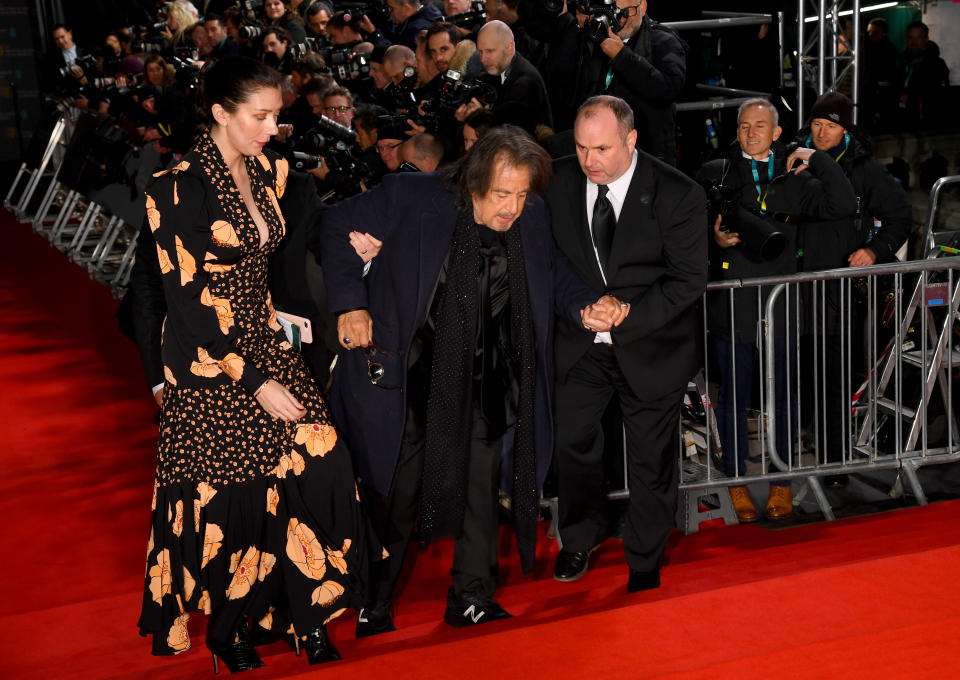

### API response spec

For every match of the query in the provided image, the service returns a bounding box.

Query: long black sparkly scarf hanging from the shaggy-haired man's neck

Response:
[420,201,539,572]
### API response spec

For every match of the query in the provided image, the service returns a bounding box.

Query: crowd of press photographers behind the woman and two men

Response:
[42,0,704,202]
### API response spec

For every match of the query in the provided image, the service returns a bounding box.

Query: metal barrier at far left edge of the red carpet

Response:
[3,109,139,298]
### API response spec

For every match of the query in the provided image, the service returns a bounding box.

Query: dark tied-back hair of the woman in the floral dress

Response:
[197,57,283,126]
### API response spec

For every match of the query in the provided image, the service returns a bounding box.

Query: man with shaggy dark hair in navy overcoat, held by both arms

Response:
[322,125,628,636]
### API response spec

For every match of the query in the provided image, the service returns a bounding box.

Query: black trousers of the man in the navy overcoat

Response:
[367,410,501,601]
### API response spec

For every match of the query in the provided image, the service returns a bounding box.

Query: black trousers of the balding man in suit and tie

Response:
[555,344,683,572]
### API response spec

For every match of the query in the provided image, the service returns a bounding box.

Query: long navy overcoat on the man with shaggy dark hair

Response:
[322,173,596,494]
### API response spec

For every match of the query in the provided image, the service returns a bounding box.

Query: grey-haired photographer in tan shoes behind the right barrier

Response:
[698,99,856,522]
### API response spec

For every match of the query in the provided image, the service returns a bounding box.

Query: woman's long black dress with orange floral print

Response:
[139,133,379,655]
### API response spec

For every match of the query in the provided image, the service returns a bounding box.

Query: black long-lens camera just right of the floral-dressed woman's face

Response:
[291,116,377,202]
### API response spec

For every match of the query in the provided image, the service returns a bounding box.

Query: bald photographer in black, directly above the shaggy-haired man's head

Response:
[457,20,553,137]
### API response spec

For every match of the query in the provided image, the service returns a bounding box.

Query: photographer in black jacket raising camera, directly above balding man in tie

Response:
[548,0,686,165]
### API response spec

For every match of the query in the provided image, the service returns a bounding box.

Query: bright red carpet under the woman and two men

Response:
[0,212,960,680]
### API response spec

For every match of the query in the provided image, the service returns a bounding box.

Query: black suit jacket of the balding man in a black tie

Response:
[547,151,707,399]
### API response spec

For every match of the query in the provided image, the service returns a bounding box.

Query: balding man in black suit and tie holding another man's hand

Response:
[547,95,707,592]
